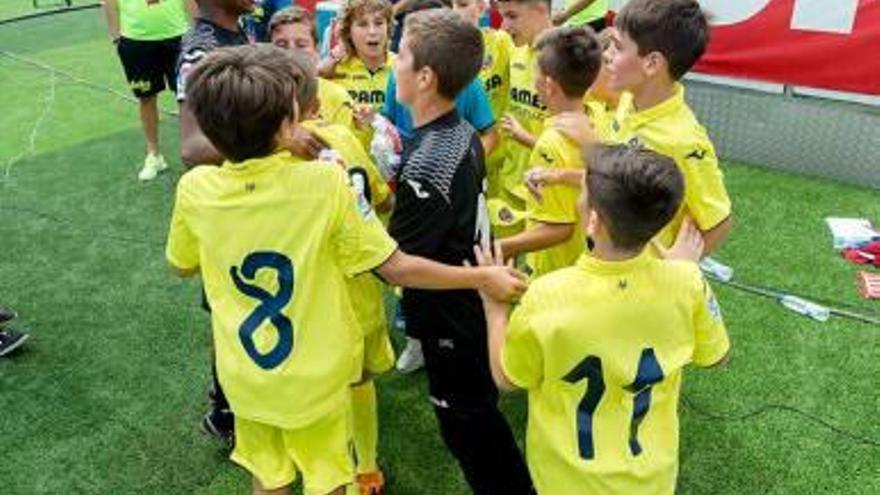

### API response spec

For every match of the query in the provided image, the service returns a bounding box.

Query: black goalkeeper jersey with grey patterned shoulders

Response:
[389,110,490,340]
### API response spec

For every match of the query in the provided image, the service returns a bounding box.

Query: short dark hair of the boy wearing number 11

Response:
[586,145,684,250]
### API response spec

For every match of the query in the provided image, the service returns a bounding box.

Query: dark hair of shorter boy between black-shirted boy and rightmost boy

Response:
[535,27,602,98]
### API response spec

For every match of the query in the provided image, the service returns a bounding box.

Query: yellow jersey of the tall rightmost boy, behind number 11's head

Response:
[613,84,731,252]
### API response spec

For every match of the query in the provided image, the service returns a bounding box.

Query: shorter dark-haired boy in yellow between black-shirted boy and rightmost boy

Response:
[501,27,602,278]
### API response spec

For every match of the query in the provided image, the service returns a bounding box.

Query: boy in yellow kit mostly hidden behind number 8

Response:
[295,53,394,495]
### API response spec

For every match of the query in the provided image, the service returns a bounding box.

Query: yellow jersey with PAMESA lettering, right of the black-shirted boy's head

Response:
[501,45,549,207]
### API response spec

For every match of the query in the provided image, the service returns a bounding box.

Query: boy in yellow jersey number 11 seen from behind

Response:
[482,145,730,495]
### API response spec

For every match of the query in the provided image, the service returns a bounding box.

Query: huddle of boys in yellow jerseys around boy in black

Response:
[167,0,731,495]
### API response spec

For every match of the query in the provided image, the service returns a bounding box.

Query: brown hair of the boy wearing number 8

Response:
[186,44,302,162]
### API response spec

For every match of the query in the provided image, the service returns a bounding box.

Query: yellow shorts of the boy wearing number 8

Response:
[230,407,354,495]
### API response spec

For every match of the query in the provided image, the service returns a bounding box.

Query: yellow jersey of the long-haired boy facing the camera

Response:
[333,53,394,149]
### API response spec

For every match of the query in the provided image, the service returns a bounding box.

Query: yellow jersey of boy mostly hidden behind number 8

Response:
[303,121,391,335]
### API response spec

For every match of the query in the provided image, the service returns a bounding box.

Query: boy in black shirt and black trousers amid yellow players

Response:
[389,9,532,495]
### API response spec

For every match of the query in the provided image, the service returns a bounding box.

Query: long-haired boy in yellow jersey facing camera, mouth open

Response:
[319,0,394,149]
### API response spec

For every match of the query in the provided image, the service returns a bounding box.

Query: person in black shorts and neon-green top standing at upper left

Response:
[104,0,195,181]
